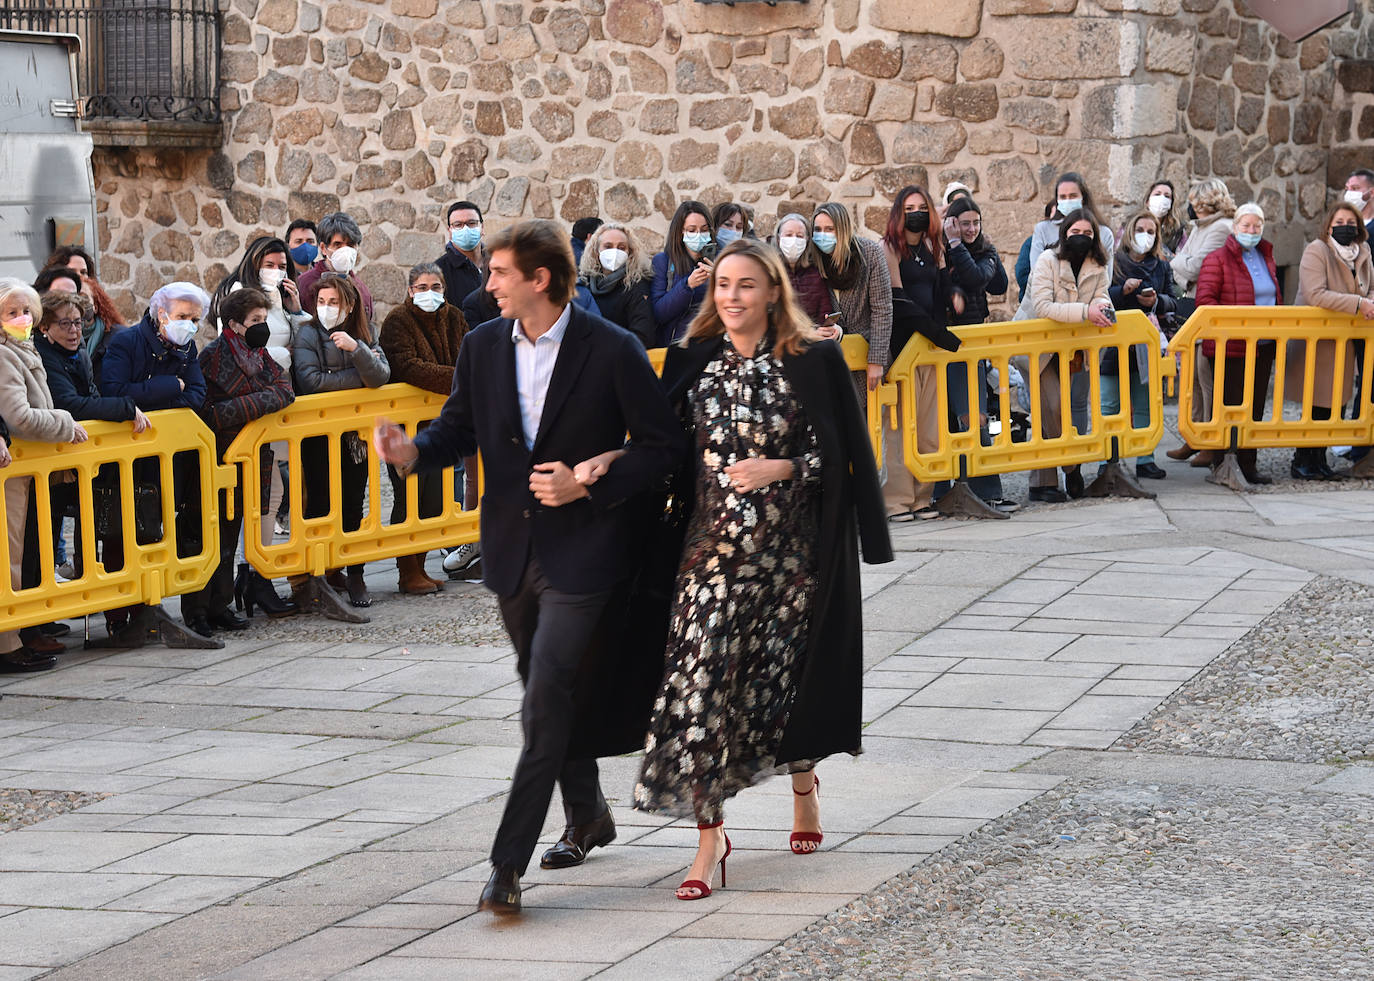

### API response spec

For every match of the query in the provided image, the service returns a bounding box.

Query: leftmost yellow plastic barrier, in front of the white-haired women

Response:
[0,409,234,629]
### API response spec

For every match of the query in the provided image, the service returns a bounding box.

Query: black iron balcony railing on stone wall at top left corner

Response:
[0,0,220,124]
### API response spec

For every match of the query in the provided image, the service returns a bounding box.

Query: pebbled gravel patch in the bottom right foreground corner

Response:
[734,782,1374,981]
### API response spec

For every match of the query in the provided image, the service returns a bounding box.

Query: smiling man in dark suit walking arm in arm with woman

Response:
[375,221,684,914]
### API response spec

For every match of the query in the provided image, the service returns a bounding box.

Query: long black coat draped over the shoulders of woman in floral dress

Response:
[651,337,892,763]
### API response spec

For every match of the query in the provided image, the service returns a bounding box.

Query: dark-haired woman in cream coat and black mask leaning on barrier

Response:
[1026,209,1113,503]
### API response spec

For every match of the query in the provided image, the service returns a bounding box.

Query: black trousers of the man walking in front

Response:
[492,556,614,875]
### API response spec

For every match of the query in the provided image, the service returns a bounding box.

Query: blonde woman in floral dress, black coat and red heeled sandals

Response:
[588,239,892,900]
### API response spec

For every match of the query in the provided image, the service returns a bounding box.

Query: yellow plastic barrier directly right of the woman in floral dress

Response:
[888,311,1173,481]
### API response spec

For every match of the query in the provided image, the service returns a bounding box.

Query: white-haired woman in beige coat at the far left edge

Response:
[0,279,87,673]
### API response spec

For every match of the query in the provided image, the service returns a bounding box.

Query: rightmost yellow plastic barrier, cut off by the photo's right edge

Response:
[1171,306,1374,449]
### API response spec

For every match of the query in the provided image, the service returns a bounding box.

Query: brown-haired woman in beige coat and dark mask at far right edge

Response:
[1283,201,1374,481]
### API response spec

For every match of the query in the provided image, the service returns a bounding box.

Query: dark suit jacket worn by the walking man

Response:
[415,306,686,598]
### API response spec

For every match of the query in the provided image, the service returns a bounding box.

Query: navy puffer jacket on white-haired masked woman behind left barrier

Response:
[100,313,205,412]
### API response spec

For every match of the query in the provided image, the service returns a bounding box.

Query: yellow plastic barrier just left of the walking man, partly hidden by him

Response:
[224,385,480,578]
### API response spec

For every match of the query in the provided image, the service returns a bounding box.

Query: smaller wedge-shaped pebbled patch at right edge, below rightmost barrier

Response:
[1117,578,1374,764]
